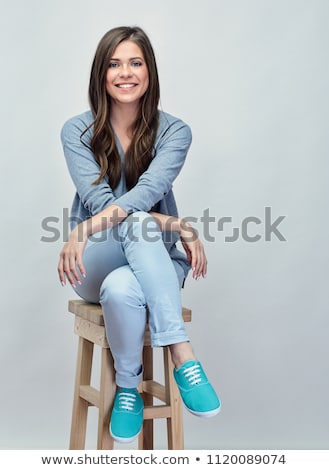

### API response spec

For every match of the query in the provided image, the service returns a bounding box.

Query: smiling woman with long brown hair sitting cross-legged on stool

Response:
[58,27,220,442]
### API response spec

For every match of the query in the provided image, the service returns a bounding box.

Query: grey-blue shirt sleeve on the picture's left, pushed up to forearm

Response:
[61,118,116,216]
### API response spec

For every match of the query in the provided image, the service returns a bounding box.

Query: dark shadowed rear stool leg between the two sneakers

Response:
[138,346,154,450]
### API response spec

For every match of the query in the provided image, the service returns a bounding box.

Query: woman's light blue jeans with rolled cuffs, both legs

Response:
[75,212,189,388]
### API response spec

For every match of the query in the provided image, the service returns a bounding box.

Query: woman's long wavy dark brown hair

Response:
[84,26,160,190]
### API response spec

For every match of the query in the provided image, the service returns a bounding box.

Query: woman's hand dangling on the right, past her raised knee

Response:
[180,220,208,279]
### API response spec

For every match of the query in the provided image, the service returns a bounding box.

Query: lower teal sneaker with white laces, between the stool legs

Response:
[110,388,144,443]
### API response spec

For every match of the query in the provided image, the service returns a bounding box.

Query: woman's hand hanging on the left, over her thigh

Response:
[57,223,88,287]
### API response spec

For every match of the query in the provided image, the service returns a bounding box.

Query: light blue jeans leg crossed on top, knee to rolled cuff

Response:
[117,212,189,347]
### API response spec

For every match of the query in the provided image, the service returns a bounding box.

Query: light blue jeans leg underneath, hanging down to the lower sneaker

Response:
[75,230,146,388]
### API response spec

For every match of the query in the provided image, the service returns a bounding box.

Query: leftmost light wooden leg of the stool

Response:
[70,336,94,450]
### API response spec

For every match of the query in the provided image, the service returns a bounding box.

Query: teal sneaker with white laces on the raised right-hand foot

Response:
[174,361,220,418]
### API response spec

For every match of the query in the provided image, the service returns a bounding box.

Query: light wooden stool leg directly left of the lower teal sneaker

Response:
[97,348,116,450]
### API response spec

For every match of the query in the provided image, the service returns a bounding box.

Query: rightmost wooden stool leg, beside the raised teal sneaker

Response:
[163,347,184,450]
